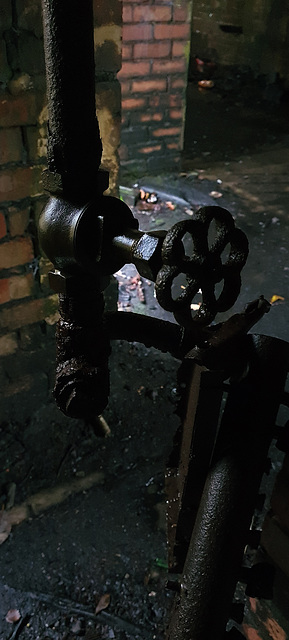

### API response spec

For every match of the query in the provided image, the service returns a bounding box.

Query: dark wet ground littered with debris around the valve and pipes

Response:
[0,81,289,640]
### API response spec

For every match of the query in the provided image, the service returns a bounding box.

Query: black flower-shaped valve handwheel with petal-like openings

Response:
[156,206,248,326]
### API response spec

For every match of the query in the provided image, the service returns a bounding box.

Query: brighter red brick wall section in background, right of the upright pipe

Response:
[118,0,191,171]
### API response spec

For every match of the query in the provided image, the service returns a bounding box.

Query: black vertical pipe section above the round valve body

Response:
[42,0,102,201]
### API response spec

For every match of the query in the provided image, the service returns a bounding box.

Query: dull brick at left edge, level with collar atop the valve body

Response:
[0,166,43,202]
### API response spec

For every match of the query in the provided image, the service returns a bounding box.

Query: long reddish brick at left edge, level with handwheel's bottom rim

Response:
[0,295,58,331]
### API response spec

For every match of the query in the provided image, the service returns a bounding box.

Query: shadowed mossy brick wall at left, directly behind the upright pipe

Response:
[0,0,122,422]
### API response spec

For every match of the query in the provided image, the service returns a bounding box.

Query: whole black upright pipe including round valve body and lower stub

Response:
[39,0,110,419]
